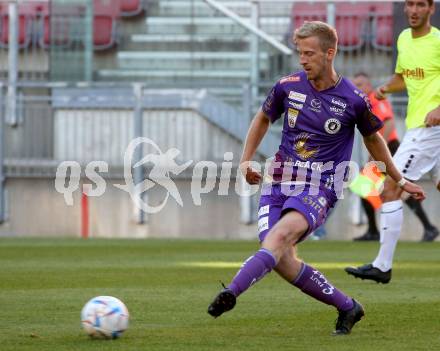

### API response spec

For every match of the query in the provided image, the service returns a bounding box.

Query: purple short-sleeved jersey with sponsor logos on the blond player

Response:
[262,71,383,201]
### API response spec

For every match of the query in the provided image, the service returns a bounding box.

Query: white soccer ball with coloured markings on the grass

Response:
[81,296,129,339]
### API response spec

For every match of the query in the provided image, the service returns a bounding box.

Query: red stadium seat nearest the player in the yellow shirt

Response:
[371,2,394,51]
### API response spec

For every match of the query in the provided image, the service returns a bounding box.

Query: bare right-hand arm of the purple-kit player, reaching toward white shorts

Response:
[364,132,425,200]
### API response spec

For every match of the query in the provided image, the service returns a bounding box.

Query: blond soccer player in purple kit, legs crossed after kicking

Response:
[208,21,424,335]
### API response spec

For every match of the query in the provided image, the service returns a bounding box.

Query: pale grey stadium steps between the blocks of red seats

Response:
[96,0,291,105]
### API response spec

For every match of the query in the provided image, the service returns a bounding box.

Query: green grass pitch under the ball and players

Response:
[0,239,440,351]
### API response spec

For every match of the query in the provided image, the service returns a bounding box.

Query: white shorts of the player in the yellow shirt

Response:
[393,126,440,186]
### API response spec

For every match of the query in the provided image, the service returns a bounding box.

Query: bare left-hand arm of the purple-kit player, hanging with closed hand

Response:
[240,109,270,184]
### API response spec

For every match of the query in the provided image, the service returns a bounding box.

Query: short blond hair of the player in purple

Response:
[293,21,338,51]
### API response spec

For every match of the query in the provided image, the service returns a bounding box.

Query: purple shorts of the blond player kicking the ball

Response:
[258,184,336,242]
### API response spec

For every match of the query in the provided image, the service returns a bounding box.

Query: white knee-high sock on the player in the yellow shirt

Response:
[373,200,403,272]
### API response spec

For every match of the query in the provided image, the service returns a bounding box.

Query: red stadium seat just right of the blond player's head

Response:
[335,3,370,50]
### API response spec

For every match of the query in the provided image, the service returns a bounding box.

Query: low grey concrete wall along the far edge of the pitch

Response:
[0,179,440,240]
